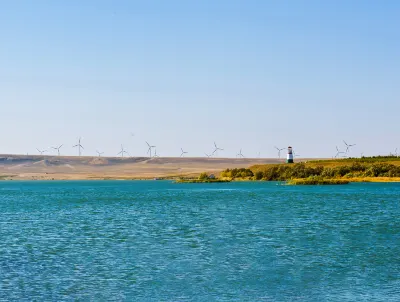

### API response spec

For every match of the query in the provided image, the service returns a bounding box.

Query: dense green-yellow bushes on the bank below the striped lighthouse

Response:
[221,162,400,180]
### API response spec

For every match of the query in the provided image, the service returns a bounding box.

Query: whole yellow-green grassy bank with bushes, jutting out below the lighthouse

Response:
[220,156,400,182]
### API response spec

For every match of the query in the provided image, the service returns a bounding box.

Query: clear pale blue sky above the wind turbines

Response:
[0,0,400,157]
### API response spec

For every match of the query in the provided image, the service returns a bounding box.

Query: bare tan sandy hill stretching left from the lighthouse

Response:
[0,154,298,179]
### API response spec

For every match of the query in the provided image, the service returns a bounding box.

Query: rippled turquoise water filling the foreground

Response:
[0,181,400,301]
